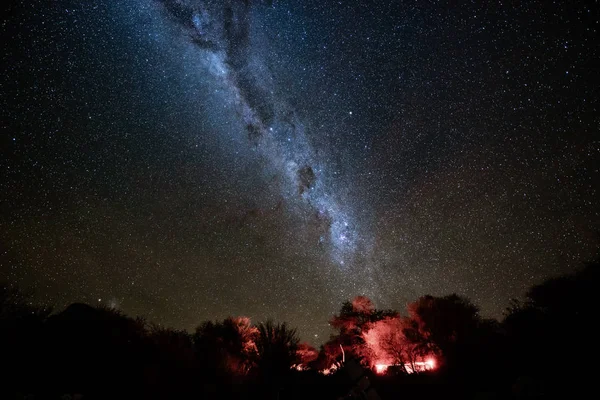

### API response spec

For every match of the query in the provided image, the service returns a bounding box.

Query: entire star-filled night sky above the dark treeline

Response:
[0,0,600,344]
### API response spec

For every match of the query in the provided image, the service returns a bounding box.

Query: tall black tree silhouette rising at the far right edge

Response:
[503,260,600,392]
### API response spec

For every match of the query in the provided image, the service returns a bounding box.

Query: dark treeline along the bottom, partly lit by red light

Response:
[0,261,600,399]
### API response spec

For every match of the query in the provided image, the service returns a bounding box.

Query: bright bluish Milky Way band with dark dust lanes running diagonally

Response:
[159,0,364,266]
